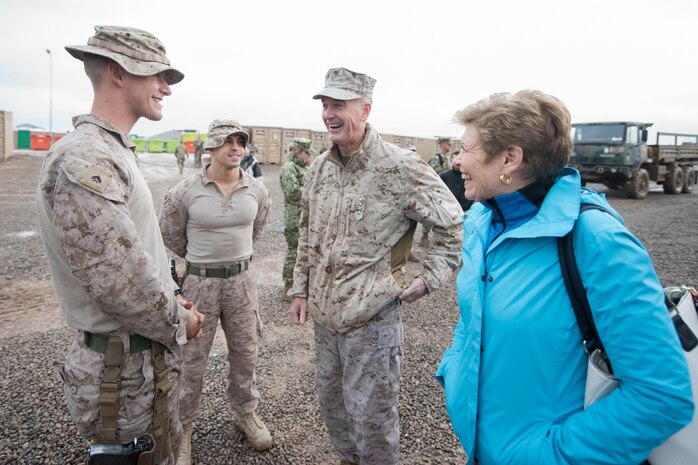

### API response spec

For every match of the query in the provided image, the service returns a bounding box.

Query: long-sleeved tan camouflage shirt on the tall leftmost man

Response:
[37,115,188,348]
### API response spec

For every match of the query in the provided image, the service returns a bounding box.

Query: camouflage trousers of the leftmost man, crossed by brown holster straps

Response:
[58,331,182,465]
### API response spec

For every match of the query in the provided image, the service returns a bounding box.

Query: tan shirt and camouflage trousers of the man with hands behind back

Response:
[160,165,271,425]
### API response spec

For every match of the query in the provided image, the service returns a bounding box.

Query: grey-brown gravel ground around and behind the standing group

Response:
[0,152,698,465]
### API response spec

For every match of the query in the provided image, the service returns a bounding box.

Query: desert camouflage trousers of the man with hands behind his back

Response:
[180,270,262,425]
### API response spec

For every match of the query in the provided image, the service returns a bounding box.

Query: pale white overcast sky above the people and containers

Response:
[0,0,698,141]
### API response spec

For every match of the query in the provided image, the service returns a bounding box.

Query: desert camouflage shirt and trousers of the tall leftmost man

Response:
[37,115,188,464]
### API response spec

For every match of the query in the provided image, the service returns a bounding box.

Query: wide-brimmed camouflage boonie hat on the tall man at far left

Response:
[65,26,184,85]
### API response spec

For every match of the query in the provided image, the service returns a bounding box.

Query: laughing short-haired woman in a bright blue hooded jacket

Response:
[437,90,693,465]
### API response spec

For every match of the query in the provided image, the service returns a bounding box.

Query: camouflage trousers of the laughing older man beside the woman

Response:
[315,302,403,465]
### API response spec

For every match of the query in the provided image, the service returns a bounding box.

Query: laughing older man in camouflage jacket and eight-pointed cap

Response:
[289,68,463,465]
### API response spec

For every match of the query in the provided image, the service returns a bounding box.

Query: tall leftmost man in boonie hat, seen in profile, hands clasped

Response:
[37,26,203,465]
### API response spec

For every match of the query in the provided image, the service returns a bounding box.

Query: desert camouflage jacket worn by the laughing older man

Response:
[290,125,463,332]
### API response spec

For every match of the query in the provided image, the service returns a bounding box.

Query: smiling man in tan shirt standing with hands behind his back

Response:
[160,120,272,465]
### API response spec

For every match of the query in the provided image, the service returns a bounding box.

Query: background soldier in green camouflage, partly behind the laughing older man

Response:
[279,137,315,302]
